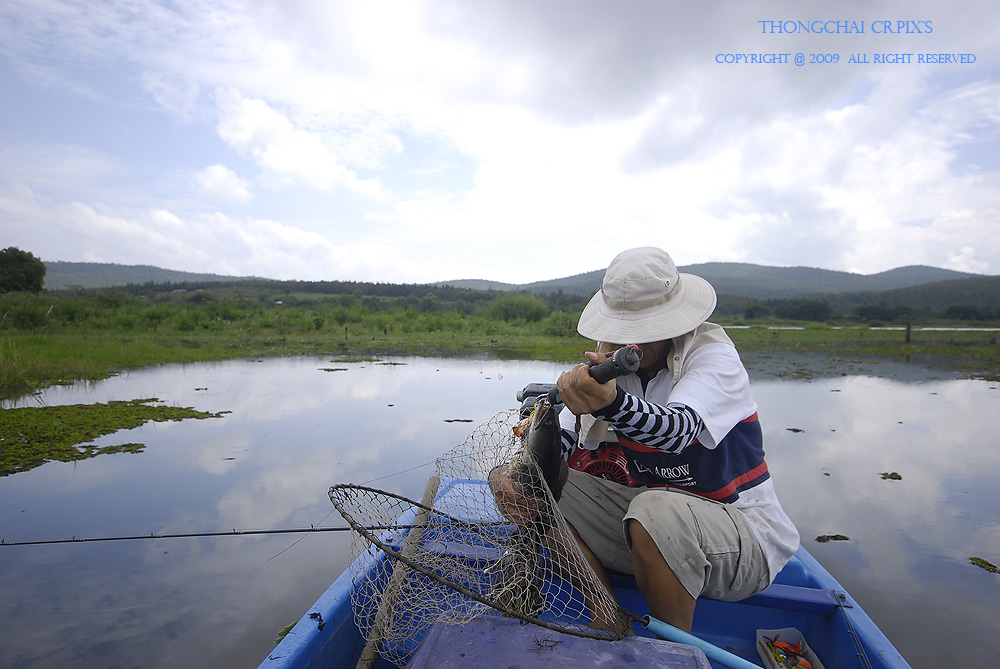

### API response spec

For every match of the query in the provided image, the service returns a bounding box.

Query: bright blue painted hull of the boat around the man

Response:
[260,482,909,669]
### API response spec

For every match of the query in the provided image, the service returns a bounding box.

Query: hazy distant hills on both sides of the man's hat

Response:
[442,263,979,300]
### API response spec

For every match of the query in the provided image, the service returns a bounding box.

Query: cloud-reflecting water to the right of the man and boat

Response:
[756,376,1000,667]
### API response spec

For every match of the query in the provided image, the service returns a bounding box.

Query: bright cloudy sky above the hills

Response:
[0,0,1000,283]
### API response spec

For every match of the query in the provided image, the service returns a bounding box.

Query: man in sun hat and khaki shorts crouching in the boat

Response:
[498,247,799,632]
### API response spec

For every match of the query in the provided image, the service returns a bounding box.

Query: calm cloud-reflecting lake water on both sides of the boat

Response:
[0,356,1000,669]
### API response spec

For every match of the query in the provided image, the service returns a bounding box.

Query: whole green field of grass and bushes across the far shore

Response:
[0,290,1000,397]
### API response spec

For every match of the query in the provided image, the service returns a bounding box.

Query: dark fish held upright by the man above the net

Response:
[508,397,569,502]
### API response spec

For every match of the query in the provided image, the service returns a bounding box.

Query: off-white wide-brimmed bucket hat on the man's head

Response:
[576,246,716,344]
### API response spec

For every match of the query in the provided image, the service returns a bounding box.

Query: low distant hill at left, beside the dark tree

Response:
[45,261,251,290]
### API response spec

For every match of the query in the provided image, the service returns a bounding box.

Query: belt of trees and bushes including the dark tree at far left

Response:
[0,247,1000,328]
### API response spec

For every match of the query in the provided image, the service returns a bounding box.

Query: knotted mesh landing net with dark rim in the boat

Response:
[330,411,630,666]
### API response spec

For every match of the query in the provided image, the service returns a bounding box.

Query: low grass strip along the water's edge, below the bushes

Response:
[0,325,1000,397]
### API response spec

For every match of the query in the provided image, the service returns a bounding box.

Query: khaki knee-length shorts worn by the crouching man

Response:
[559,470,771,601]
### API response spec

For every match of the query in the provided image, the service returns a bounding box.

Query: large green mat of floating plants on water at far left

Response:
[0,397,227,476]
